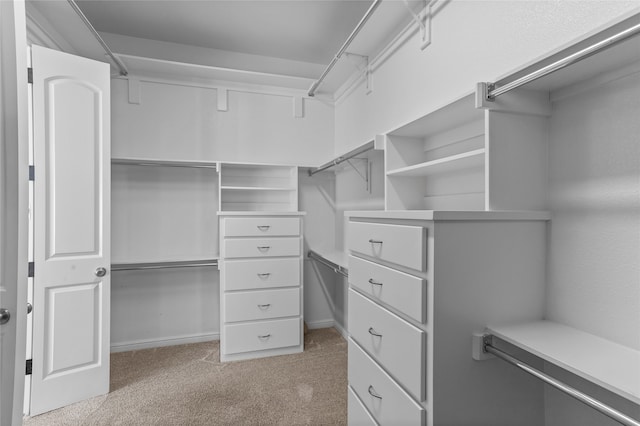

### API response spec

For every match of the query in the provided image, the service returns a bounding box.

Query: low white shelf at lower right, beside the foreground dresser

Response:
[487,321,640,404]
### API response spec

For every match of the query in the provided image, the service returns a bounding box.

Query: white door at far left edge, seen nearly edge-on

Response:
[0,0,29,425]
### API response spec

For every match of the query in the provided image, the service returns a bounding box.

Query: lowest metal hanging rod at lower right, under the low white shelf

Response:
[483,334,640,426]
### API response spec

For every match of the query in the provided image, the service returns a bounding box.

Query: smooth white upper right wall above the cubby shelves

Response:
[335,1,638,152]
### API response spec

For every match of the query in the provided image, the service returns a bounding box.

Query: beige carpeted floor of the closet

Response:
[24,328,347,426]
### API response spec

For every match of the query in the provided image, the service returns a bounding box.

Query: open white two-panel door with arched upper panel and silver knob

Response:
[31,46,111,415]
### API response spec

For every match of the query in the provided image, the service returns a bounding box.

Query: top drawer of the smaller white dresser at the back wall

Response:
[223,217,300,237]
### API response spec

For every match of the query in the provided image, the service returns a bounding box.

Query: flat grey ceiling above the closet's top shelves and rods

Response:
[77,0,372,64]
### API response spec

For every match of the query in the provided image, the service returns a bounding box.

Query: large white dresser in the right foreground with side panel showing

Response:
[346,210,548,425]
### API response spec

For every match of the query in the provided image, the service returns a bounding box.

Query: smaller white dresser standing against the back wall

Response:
[219,212,304,361]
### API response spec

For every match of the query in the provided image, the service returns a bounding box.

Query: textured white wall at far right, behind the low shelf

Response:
[545,68,640,426]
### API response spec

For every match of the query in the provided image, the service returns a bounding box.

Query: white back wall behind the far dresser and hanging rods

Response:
[111,70,334,350]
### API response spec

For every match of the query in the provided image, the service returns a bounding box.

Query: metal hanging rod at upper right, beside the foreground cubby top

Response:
[485,20,640,101]
